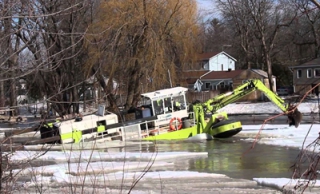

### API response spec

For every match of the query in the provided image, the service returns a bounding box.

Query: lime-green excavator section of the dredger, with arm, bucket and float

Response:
[145,79,302,140]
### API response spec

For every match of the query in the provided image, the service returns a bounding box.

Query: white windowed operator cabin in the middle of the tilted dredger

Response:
[136,87,188,126]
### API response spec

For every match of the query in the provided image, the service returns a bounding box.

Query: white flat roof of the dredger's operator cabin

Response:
[141,87,188,100]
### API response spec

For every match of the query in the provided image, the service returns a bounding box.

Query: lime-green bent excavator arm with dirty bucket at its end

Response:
[202,79,302,127]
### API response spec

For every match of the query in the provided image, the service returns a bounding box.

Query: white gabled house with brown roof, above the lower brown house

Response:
[198,51,237,71]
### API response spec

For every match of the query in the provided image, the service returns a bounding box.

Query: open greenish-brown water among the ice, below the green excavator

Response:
[126,138,299,180]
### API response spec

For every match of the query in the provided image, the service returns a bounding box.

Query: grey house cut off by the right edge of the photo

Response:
[290,58,320,94]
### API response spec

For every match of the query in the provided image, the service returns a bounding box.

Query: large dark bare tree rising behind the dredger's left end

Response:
[11,0,93,116]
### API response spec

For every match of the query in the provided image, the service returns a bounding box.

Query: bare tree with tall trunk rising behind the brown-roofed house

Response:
[217,0,296,90]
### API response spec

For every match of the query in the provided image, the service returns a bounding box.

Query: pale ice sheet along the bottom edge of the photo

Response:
[16,171,282,194]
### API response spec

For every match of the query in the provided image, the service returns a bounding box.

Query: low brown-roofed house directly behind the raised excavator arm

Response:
[184,69,276,101]
